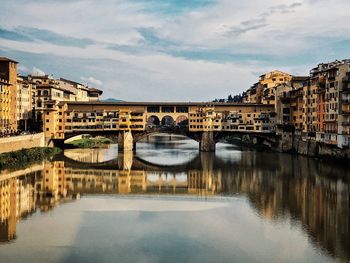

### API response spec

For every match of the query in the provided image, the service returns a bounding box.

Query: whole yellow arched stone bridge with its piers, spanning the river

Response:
[44,102,276,151]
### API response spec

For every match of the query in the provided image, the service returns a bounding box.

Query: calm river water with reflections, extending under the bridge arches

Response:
[0,137,350,262]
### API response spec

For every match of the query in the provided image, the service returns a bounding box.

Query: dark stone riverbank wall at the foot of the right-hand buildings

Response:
[277,132,350,161]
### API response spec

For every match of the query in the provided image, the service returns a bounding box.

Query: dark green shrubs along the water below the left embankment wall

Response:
[0,147,61,170]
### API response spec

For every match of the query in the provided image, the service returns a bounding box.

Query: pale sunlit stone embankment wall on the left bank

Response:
[0,133,45,153]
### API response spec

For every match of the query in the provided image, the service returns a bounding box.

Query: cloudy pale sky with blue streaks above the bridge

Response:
[0,0,350,101]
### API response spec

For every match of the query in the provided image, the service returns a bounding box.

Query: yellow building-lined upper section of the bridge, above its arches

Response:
[44,102,275,139]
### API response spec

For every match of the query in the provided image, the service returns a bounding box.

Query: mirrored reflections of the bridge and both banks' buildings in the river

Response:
[0,139,350,261]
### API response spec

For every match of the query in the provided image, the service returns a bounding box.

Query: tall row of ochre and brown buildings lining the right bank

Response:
[276,60,350,148]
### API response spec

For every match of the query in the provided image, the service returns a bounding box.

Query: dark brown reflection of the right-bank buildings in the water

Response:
[222,153,350,262]
